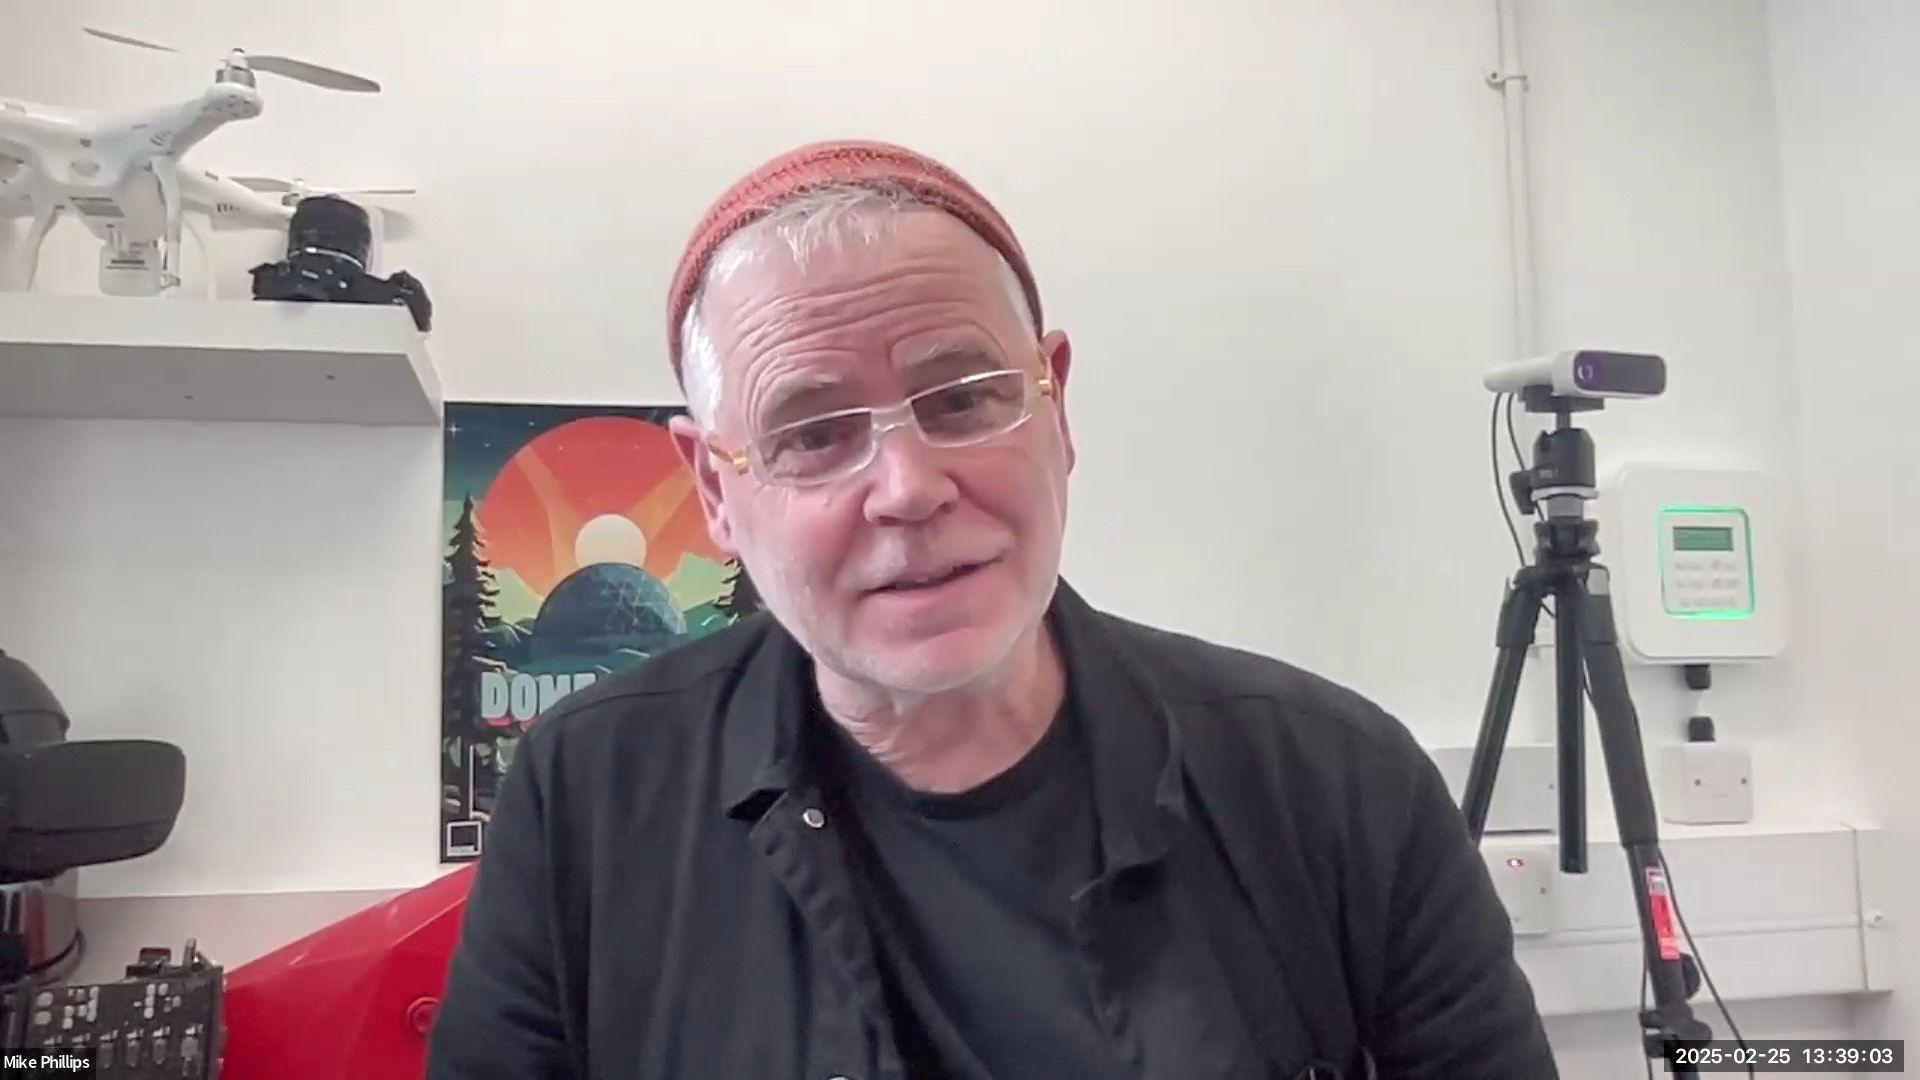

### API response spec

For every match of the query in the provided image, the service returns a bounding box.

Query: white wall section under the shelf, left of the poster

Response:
[0,419,440,896]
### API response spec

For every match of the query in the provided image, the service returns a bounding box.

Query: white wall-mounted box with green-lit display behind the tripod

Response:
[1599,463,1788,663]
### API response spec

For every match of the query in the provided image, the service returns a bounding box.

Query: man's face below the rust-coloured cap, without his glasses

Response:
[674,211,1073,694]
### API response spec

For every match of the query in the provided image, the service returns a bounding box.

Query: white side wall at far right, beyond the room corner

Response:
[1768,0,1920,1038]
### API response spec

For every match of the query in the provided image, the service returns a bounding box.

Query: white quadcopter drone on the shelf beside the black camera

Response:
[0,27,413,296]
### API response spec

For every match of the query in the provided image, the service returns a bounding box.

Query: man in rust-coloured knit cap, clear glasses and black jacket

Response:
[430,142,1555,1080]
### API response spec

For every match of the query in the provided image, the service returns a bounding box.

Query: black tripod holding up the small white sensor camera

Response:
[1461,386,1713,1076]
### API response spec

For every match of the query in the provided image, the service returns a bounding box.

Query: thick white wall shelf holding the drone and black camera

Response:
[0,292,442,425]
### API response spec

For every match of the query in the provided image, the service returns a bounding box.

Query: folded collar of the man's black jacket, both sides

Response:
[720,578,1187,871]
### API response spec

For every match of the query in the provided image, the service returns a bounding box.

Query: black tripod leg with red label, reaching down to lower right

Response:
[1561,565,1713,1076]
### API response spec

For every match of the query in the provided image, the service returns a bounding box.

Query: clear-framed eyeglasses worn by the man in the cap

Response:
[707,369,1054,488]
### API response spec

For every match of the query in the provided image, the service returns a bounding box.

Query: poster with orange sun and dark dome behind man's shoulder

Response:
[440,402,758,861]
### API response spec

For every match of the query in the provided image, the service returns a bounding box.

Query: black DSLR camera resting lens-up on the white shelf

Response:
[253,194,434,331]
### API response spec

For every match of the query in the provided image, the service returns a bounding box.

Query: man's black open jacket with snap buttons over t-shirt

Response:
[428,582,1555,1080]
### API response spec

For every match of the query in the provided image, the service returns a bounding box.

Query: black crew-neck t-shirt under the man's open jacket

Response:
[822,707,1123,1080]
